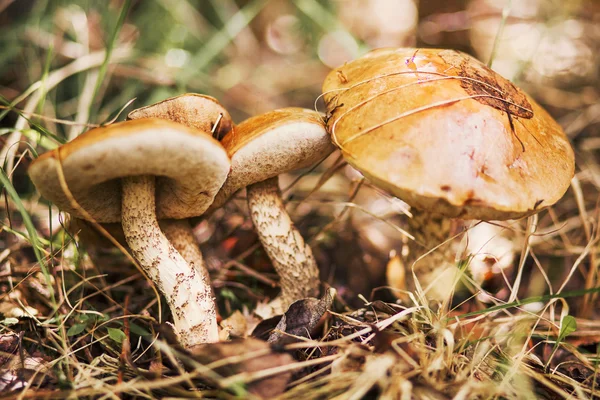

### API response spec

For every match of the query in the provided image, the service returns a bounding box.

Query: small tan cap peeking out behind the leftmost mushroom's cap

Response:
[127,93,233,138]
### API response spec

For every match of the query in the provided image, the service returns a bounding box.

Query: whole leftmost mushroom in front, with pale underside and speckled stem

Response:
[29,118,230,348]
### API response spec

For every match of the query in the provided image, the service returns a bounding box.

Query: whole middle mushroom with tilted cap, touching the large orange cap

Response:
[210,108,333,308]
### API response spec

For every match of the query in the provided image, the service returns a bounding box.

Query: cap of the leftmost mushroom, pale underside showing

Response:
[29,118,230,222]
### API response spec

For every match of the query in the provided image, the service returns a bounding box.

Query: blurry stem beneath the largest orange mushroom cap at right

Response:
[403,208,459,300]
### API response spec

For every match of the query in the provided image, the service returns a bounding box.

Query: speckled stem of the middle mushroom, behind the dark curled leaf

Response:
[246,177,319,308]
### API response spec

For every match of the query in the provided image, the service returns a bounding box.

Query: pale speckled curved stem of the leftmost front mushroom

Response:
[122,176,219,348]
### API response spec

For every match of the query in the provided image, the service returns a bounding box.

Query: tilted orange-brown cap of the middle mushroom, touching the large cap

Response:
[211,107,334,209]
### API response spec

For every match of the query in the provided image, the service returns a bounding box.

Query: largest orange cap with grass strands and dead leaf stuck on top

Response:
[323,49,574,220]
